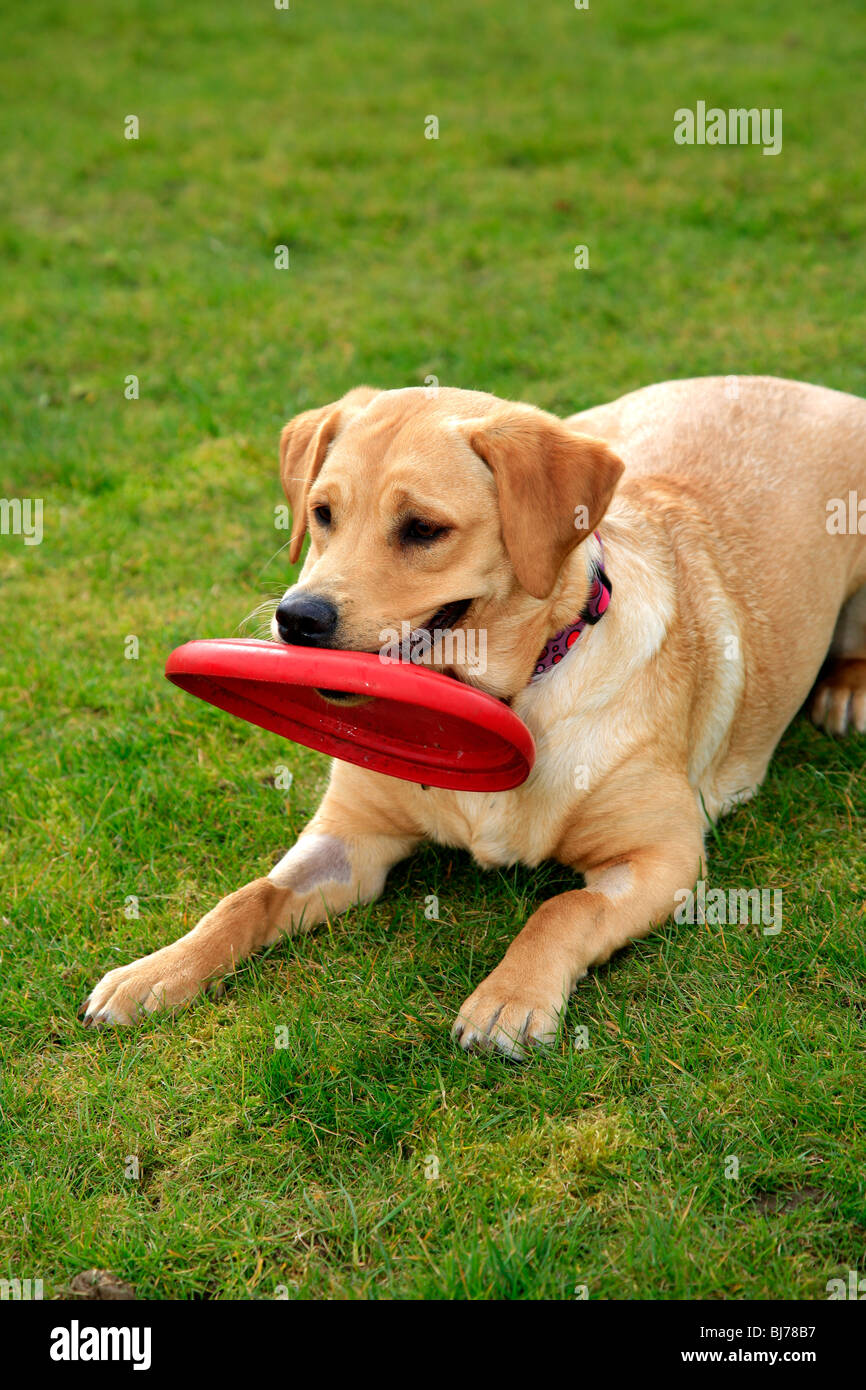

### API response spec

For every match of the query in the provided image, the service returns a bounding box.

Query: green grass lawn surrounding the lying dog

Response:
[0,0,866,1298]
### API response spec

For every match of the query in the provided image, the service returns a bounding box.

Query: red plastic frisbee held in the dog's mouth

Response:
[165,638,535,791]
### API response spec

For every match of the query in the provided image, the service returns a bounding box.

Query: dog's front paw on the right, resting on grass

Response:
[452,965,564,1062]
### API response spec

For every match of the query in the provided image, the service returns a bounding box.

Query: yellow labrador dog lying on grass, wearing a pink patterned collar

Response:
[85,377,866,1056]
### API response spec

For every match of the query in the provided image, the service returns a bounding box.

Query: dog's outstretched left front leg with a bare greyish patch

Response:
[83,783,418,1024]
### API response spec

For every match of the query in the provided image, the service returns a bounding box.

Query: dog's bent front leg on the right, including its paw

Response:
[453,794,703,1059]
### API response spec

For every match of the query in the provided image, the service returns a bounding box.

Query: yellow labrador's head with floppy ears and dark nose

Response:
[272,386,623,696]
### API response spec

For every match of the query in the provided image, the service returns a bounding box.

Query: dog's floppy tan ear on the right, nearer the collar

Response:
[459,406,624,599]
